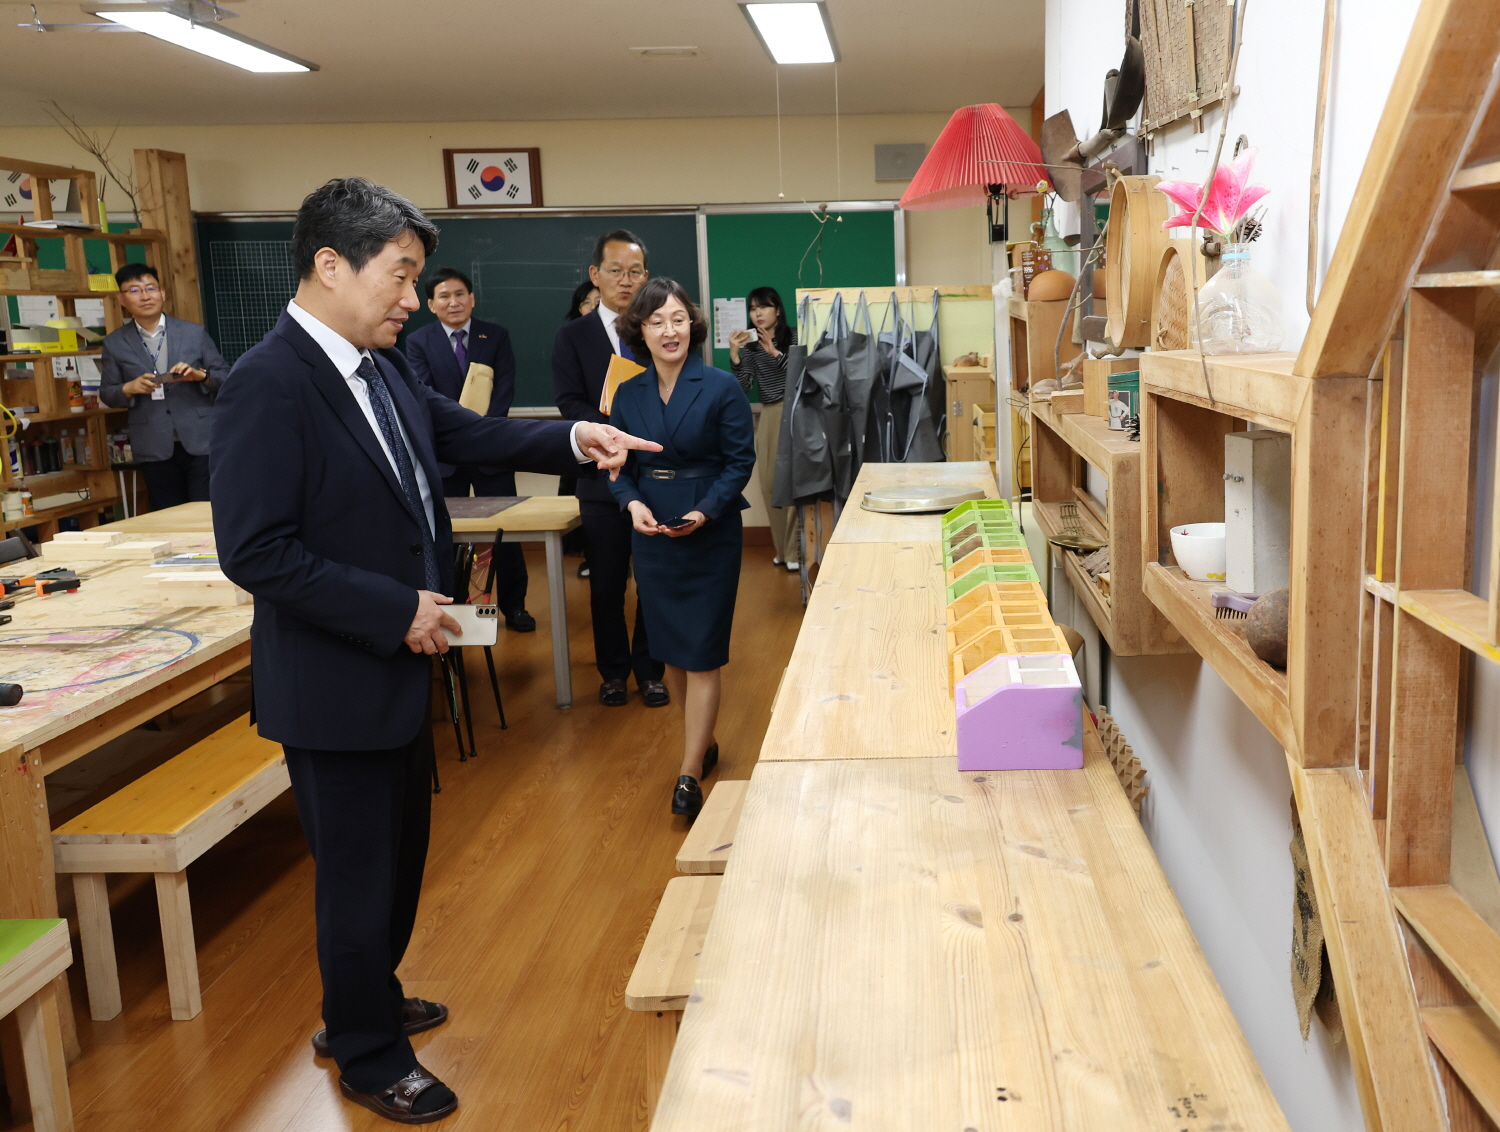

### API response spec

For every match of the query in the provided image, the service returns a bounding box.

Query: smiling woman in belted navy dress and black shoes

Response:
[609,279,755,820]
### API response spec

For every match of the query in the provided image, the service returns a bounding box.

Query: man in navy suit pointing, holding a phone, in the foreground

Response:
[213,177,657,1125]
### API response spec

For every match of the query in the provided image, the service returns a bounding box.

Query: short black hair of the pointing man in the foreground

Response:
[291,177,438,279]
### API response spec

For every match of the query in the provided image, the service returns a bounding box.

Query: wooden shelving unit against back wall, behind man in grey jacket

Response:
[0,157,174,538]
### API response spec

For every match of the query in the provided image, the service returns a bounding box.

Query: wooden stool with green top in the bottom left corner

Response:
[0,919,74,1132]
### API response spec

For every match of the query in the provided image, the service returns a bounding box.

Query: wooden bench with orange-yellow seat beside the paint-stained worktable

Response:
[53,715,291,1021]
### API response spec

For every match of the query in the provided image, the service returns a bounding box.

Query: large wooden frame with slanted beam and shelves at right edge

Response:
[1142,0,1500,1132]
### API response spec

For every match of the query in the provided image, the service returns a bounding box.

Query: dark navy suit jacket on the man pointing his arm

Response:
[210,313,578,751]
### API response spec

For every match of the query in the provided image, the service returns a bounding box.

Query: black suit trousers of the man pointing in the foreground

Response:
[285,723,434,1093]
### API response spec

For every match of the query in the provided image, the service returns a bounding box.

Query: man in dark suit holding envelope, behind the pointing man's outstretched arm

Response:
[407,267,537,633]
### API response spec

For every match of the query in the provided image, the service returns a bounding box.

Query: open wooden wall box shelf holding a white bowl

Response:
[1140,351,1320,751]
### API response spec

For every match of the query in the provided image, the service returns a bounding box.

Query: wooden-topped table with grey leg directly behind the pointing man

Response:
[99,495,581,708]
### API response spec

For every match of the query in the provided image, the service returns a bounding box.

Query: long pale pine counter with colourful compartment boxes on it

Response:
[653,465,1287,1132]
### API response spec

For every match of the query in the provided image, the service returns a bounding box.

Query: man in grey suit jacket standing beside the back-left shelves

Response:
[99,264,230,510]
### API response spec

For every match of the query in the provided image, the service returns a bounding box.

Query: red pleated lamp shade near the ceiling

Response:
[902,102,1050,210]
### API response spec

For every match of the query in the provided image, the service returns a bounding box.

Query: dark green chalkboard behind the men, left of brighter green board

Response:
[198,213,698,406]
